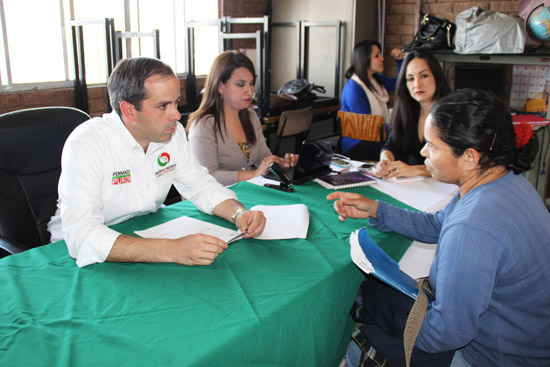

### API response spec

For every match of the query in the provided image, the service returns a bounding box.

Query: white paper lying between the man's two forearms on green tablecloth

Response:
[135,217,240,243]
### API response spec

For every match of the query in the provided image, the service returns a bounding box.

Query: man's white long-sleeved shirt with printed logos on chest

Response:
[48,112,236,267]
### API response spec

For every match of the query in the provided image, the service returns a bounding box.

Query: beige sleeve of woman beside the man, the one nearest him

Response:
[189,117,238,185]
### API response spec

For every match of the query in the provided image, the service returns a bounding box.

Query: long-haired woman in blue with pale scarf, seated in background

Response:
[341,41,404,159]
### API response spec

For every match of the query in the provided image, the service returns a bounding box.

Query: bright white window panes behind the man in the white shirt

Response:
[0,0,219,90]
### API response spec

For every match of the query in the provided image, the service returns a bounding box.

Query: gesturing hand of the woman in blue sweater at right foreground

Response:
[327,191,378,222]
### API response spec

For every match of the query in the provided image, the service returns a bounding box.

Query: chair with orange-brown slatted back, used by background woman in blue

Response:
[338,111,387,161]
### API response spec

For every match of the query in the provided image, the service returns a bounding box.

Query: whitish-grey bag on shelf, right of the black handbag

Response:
[455,6,526,54]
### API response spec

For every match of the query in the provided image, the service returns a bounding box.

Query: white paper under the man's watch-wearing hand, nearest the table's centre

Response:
[250,204,309,240]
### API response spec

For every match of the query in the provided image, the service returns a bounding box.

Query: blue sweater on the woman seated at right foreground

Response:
[369,172,550,366]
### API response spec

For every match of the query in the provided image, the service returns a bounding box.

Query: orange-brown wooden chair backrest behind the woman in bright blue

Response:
[338,111,387,142]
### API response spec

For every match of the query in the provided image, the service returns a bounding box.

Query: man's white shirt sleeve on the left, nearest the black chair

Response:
[59,138,120,267]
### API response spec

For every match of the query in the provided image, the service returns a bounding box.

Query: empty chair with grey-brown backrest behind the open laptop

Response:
[273,107,313,154]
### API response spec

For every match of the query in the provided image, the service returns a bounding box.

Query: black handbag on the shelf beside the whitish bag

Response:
[404,13,456,51]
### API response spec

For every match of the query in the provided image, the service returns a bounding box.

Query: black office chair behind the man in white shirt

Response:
[0,107,90,257]
